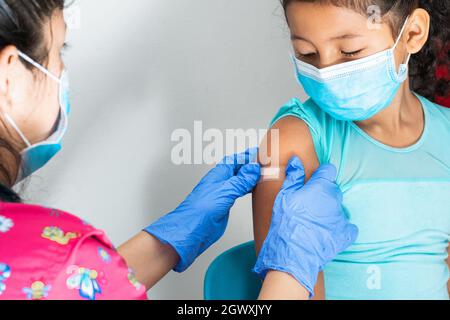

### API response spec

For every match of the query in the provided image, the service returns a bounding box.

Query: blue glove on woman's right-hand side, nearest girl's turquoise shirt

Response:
[253,157,358,297]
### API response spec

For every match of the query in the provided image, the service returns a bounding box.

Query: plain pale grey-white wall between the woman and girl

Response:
[17,0,302,299]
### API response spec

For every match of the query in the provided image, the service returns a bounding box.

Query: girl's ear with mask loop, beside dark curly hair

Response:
[406,8,431,54]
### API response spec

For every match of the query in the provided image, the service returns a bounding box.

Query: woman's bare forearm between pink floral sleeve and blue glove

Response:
[118,232,180,290]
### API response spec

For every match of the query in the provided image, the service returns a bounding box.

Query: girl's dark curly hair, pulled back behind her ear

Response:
[281,0,450,101]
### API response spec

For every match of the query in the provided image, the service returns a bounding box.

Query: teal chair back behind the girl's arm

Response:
[204,241,262,300]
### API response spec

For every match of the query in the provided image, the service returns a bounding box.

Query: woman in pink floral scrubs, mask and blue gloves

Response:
[0,0,357,300]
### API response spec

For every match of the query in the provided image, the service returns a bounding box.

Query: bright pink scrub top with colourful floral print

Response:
[0,203,147,300]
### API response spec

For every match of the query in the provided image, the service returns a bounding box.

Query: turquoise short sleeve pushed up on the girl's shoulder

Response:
[270,98,328,164]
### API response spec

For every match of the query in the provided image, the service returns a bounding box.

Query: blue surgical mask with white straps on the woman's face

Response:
[5,52,70,183]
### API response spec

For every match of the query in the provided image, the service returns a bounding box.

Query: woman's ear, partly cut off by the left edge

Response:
[0,46,20,110]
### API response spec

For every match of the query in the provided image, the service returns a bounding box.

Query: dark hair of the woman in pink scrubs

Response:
[0,0,64,202]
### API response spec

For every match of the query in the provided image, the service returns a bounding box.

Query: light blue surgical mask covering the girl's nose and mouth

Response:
[293,17,411,121]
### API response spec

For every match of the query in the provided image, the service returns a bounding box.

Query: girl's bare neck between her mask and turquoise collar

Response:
[356,81,425,148]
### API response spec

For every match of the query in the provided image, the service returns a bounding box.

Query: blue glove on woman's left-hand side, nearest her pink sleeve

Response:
[144,148,261,272]
